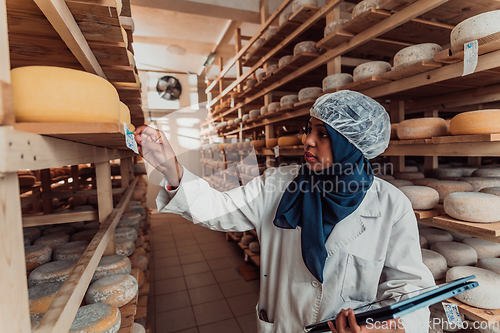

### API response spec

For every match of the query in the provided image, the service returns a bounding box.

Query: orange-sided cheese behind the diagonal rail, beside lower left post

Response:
[28,282,64,323]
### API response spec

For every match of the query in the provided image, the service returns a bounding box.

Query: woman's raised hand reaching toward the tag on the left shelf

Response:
[134,125,183,186]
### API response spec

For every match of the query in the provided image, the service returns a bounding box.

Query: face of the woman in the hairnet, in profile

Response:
[304,117,333,171]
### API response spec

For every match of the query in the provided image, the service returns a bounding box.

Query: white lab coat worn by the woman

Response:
[156,166,434,333]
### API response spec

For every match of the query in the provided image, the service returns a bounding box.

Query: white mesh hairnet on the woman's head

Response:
[311,90,391,159]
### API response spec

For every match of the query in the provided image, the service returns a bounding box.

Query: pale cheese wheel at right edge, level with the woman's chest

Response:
[444,192,500,223]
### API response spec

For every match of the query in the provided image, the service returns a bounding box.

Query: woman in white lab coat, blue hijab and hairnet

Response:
[135,90,434,333]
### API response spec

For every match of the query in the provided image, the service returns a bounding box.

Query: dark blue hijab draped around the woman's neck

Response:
[274,123,374,283]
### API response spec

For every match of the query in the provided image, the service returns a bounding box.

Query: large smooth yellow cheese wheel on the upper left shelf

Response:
[11,66,120,123]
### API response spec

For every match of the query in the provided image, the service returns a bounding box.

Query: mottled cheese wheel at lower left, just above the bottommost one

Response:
[85,274,138,307]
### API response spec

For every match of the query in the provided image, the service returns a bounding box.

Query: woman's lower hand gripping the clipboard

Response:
[328,309,405,333]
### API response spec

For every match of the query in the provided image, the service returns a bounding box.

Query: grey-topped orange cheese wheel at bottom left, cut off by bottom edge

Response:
[68,303,122,333]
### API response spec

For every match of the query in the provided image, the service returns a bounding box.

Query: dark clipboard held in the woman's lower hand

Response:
[306,275,479,333]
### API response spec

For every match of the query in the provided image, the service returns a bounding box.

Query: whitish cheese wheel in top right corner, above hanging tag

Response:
[450,10,500,52]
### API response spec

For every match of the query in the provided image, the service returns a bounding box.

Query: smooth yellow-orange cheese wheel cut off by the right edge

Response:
[450,110,500,135]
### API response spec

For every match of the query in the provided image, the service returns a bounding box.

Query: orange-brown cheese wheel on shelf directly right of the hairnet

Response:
[398,117,446,140]
